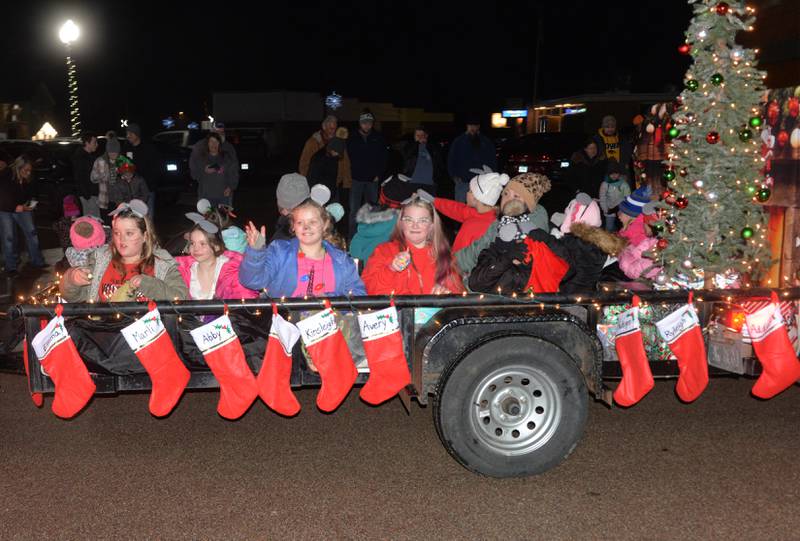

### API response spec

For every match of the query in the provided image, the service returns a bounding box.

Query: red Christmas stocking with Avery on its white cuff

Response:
[358,304,411,405]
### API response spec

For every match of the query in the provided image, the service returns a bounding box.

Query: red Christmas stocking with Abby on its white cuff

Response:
[191,315,258,420]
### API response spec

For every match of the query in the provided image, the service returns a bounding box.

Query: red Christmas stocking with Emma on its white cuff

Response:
[31,304,97,419]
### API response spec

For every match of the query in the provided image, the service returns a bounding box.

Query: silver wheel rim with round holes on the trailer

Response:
[470,365,563,456]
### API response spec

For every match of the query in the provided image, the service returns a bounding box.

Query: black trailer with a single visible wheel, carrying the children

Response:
[10,286,800,477]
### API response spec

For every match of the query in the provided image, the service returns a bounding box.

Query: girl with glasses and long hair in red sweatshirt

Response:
[361,197,464,295]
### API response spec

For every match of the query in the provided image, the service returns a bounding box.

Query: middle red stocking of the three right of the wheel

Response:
[656,291,708,402]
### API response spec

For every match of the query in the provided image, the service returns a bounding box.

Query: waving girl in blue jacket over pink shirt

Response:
[239,199,367,297]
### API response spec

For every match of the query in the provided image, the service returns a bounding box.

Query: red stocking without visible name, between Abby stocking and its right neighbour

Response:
[257,304,300,417]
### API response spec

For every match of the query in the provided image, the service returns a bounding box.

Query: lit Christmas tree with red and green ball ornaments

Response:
[655,0,770,287]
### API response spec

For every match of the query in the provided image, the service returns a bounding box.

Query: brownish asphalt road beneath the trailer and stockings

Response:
[0,374,800,539]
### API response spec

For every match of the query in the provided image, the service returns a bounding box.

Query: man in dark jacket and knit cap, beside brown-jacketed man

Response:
[347,110,389,237]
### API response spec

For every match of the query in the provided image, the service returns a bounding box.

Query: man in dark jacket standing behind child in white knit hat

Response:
[447,117,497,203]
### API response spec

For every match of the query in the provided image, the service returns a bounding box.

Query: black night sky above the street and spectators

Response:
[0,0,691,131]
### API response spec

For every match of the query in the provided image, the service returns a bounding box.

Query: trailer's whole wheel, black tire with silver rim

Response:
[433,336,589,477]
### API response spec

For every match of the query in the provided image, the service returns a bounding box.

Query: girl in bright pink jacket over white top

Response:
[175,220,258,300]
